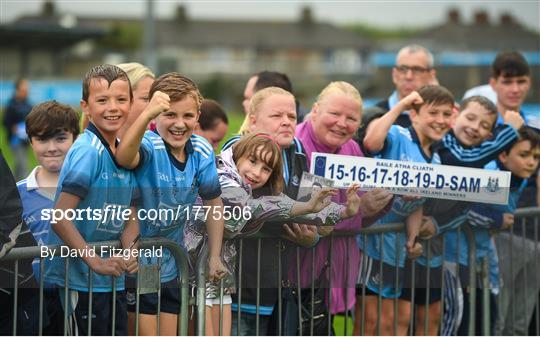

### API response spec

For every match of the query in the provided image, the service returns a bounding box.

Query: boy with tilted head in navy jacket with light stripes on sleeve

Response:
[416,96,523,334]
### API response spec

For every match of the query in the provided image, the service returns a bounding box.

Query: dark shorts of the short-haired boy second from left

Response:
[70,290,127,336]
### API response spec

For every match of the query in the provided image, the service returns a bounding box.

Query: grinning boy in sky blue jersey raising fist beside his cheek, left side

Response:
[116,73,227,335]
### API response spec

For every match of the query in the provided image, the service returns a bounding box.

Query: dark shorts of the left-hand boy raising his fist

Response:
[127,280,182,315]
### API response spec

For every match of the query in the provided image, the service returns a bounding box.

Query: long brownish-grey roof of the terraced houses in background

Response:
[71,17,371,49]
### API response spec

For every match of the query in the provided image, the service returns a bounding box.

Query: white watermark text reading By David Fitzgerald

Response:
[40,246,163,260]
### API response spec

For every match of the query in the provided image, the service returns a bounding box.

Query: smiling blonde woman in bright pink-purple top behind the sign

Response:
[290,82,392,314]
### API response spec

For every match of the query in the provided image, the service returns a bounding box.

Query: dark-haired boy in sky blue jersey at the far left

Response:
[17,101,79,335]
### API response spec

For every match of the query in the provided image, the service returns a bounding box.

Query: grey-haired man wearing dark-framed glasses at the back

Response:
[376,44,437,128]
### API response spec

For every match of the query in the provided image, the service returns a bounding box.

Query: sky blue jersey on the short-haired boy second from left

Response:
[45,124,136,292]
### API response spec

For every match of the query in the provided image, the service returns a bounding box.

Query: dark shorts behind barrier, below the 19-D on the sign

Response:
[400,260,442,305]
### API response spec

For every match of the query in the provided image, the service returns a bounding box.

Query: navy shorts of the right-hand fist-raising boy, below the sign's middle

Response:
[356,254,403,298]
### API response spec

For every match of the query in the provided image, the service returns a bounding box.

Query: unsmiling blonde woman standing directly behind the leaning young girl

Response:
[223,87,318,335]
